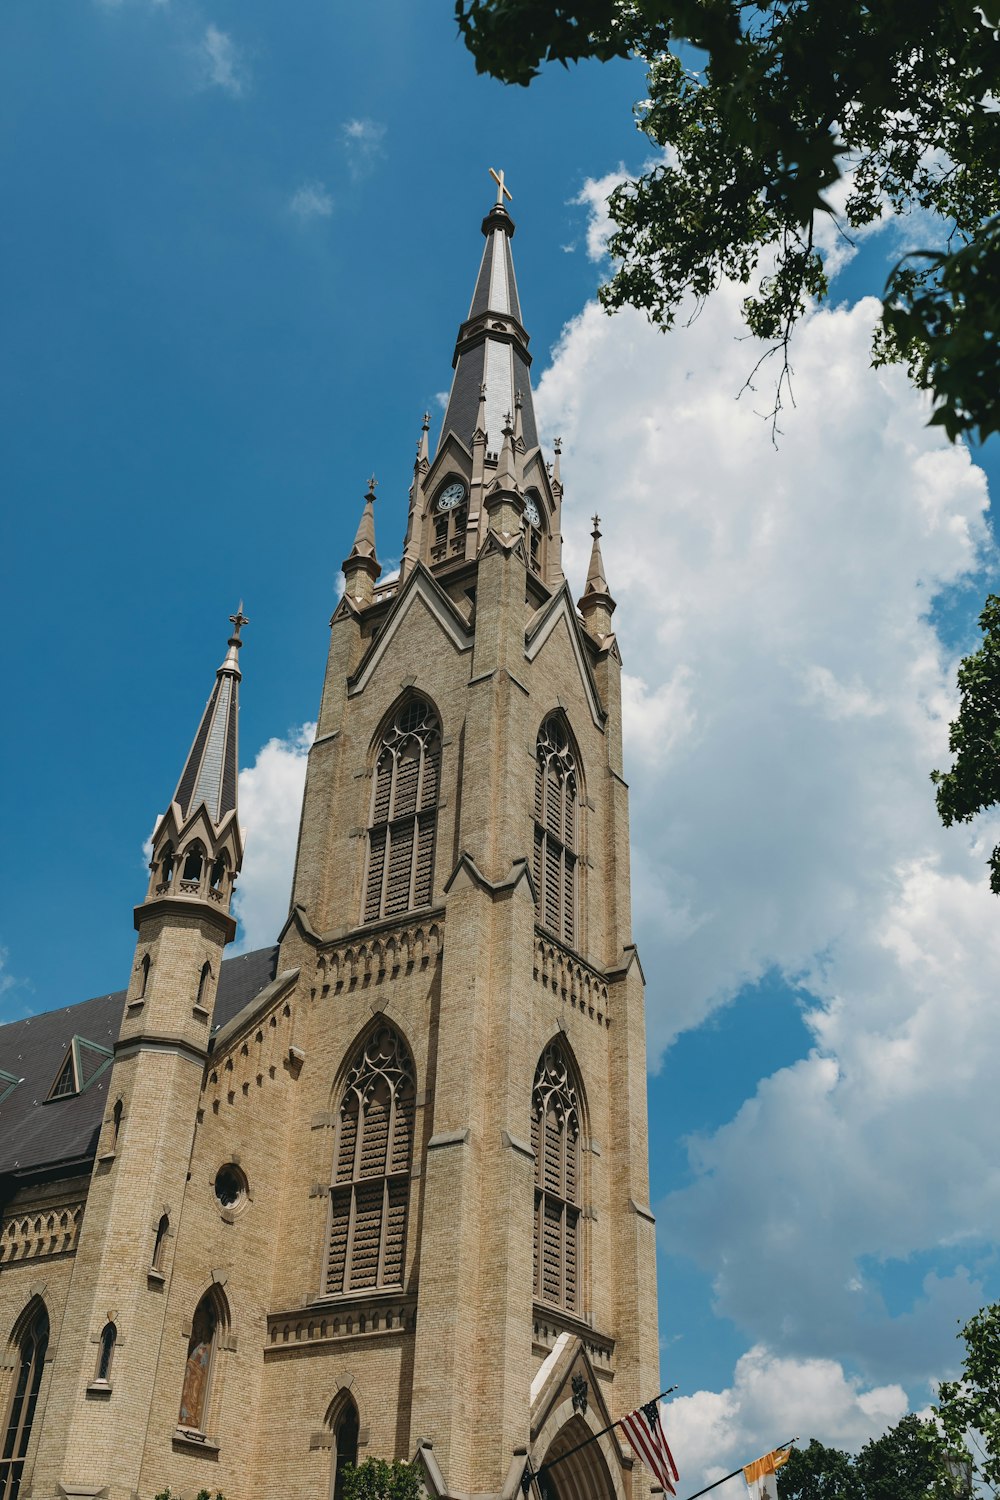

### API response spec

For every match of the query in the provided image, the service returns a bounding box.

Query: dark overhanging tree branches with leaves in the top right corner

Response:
[456,0,1000,438]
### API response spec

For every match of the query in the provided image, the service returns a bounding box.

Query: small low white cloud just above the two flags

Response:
[663,1344,909,1494]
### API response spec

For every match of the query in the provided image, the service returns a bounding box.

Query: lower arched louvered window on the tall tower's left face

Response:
[325,1026,417,1296]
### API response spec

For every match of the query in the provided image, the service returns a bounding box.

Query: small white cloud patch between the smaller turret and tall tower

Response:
[232,725,316,951]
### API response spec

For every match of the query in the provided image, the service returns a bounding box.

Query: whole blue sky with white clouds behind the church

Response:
[0,0,1000,1488]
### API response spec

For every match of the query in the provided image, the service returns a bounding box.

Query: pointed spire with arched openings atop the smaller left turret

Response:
[135,612,249,918]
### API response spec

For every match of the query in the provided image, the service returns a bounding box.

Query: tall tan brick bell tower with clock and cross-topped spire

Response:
[277,174,658,1500]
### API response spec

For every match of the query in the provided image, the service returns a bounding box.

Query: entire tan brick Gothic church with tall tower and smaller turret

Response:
[0,182,658,1500]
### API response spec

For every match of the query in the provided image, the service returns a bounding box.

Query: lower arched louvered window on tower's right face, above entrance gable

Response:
[531,1041,580,1313]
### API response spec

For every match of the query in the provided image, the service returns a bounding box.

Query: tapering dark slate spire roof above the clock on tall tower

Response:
[438,204,538,455]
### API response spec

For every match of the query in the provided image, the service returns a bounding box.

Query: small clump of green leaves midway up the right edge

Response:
[931,594,1000,888]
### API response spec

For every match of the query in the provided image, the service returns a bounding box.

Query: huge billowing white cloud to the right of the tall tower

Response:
[537,185,1000,1404]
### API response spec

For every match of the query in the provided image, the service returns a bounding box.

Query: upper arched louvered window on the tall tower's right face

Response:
[535,714,577,947]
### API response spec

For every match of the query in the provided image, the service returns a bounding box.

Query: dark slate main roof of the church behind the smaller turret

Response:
[0,948,277,1176]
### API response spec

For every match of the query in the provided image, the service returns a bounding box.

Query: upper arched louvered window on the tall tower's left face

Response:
[363,698,441,923]
